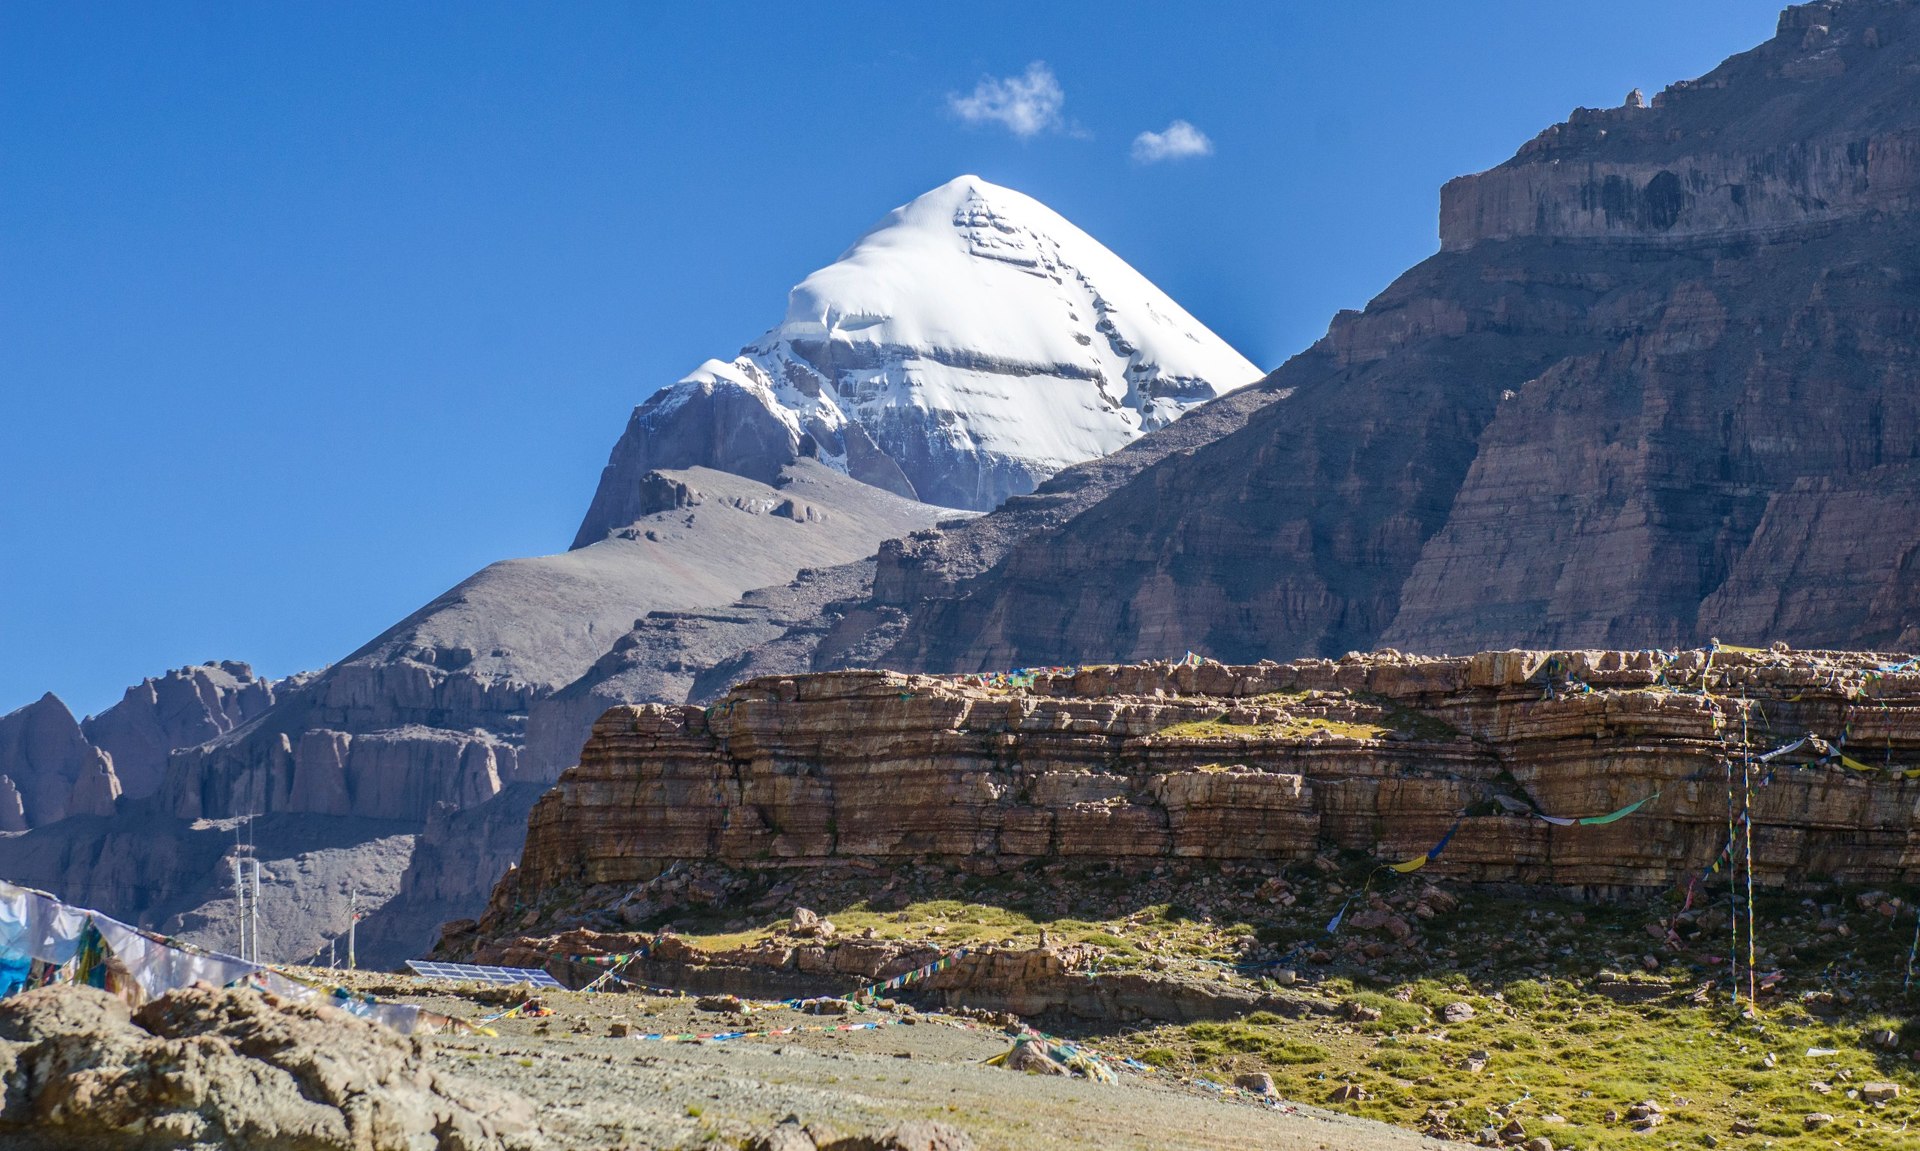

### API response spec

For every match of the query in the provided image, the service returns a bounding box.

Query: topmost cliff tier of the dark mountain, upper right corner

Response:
[1440,0,1920,250]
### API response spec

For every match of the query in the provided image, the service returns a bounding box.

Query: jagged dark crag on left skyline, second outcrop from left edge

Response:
[81,659,278,799]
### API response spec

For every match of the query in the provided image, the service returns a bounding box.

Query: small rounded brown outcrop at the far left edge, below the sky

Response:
[0,692,121,830]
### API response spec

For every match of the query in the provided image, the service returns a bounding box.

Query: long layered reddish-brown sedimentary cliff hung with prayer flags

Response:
[482,649,1920,934]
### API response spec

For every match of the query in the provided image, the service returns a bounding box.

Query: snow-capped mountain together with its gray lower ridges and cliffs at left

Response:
[0,177,1258,961]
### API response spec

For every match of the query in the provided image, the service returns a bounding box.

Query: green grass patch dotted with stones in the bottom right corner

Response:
[1125,976,1920,1151]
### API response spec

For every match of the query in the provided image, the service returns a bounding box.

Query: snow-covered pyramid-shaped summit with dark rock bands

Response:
[578,175,1261,544]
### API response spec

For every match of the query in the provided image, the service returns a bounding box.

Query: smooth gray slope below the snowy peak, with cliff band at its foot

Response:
[163,461,939,822]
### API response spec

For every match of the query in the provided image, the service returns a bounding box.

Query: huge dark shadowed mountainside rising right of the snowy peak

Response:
[871,0,1920,671]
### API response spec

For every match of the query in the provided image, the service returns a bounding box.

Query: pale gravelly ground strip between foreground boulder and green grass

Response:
[311,972,1446,1151]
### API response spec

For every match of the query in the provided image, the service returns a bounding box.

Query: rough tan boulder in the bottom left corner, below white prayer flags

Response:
[0,984,541,1151]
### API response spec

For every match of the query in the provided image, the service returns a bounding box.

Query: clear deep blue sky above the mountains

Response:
[0,0,1778,713]
